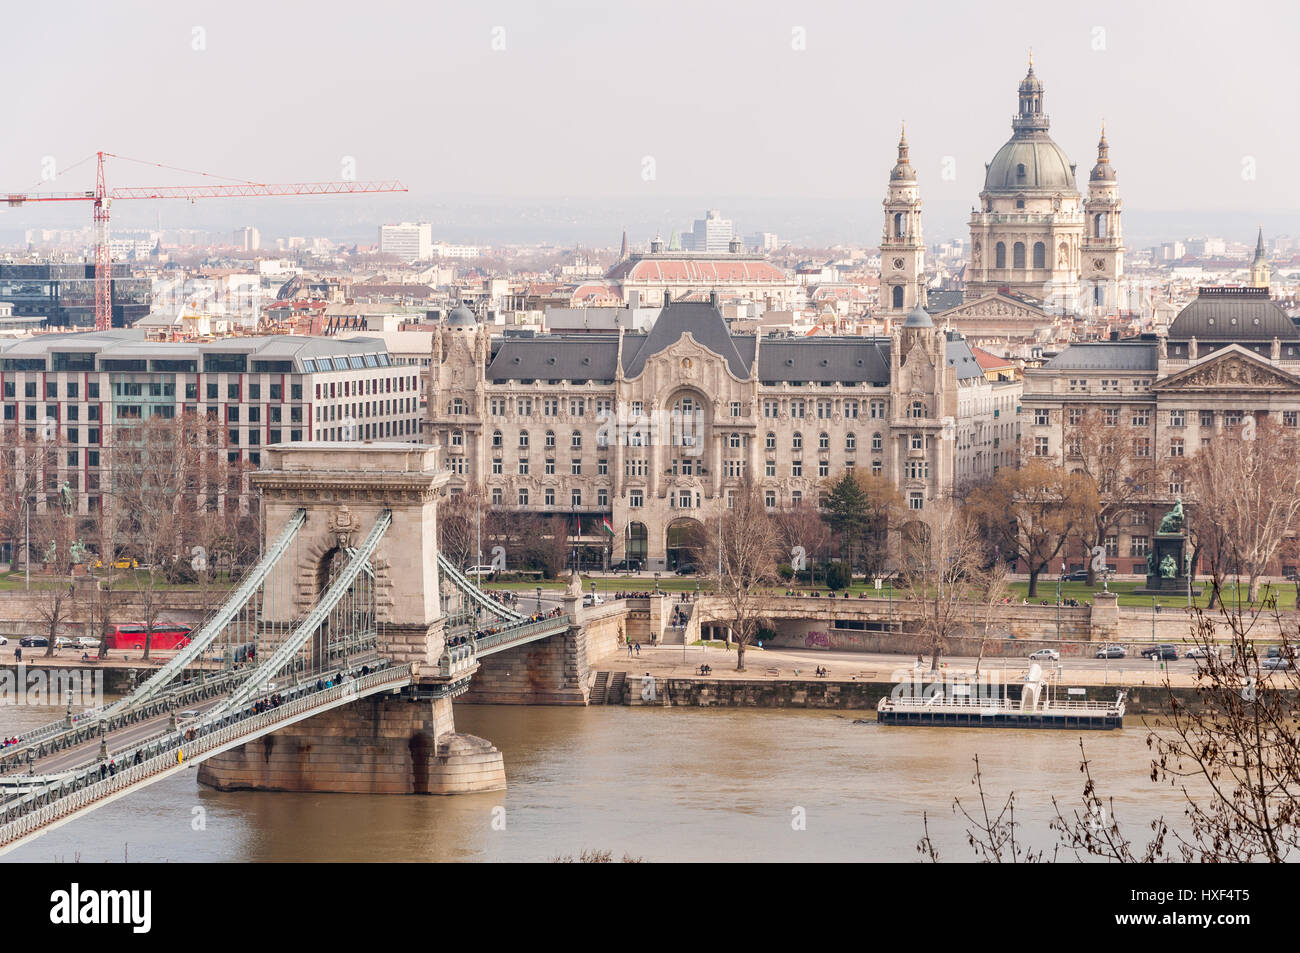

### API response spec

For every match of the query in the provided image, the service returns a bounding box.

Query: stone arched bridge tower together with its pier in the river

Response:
[199,442,506,794]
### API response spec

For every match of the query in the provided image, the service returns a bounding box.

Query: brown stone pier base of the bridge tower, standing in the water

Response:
[199,694,506,794]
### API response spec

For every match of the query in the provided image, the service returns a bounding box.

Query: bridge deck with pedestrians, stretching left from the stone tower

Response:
[0,657,411,854]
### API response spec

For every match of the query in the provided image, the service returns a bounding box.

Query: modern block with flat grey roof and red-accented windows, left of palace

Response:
[0,330,421,514]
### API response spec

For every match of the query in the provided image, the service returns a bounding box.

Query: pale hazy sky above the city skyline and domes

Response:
[0,0,1300,241]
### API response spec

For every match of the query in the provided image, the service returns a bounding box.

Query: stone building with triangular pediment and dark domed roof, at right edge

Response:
[1022,284,1300,572]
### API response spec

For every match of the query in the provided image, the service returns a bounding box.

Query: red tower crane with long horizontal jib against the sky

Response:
[0,152,406,330]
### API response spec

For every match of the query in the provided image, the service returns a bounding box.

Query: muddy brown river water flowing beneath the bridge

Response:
[0,705,1182,862]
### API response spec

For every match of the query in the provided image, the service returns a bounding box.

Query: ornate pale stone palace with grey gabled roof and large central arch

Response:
[426,295,1021,569]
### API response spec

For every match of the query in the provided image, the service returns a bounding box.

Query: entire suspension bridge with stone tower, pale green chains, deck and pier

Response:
[0,443,580,853]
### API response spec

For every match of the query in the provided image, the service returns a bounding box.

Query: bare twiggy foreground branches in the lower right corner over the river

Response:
[918,599,1300,863]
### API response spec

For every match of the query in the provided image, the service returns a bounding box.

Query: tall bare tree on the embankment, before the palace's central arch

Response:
[706,480,781,672]
